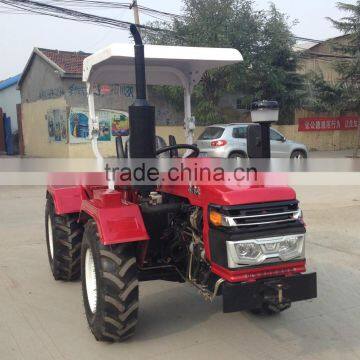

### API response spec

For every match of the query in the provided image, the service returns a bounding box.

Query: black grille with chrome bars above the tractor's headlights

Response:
[222,201,299,230]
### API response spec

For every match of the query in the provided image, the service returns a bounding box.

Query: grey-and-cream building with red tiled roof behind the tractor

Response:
[19,48,183,158]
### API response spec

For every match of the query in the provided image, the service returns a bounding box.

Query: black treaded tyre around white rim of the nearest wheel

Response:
[83,220,139,342]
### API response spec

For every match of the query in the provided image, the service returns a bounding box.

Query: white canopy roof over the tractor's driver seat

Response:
[83,44,243,88]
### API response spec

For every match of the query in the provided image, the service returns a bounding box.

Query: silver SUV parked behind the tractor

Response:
[196,124,308,159]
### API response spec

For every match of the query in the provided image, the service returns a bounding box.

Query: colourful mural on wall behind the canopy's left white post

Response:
[69,108,129,144]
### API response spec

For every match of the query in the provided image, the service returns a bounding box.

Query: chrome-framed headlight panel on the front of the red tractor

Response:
[226,235,305,269]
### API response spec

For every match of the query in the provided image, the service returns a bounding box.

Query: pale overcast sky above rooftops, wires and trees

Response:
[0,0,355,79]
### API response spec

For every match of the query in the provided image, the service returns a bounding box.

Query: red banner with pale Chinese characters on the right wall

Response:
[299,115,360,131]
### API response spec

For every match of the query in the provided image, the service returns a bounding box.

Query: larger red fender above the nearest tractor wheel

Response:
[80,189,150,245]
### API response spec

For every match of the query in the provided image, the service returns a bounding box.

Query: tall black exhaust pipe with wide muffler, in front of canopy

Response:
[129,24,156,159]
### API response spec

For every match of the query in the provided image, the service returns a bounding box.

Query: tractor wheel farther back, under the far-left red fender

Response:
[45,198,84,281]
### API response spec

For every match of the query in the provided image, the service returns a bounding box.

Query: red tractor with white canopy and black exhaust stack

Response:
[45,26,317,342]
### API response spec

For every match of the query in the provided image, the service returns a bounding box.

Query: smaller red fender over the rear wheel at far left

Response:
[47,186,88,215]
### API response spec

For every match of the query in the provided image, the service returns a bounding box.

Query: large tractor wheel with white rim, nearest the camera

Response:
[81,220,139,342]
